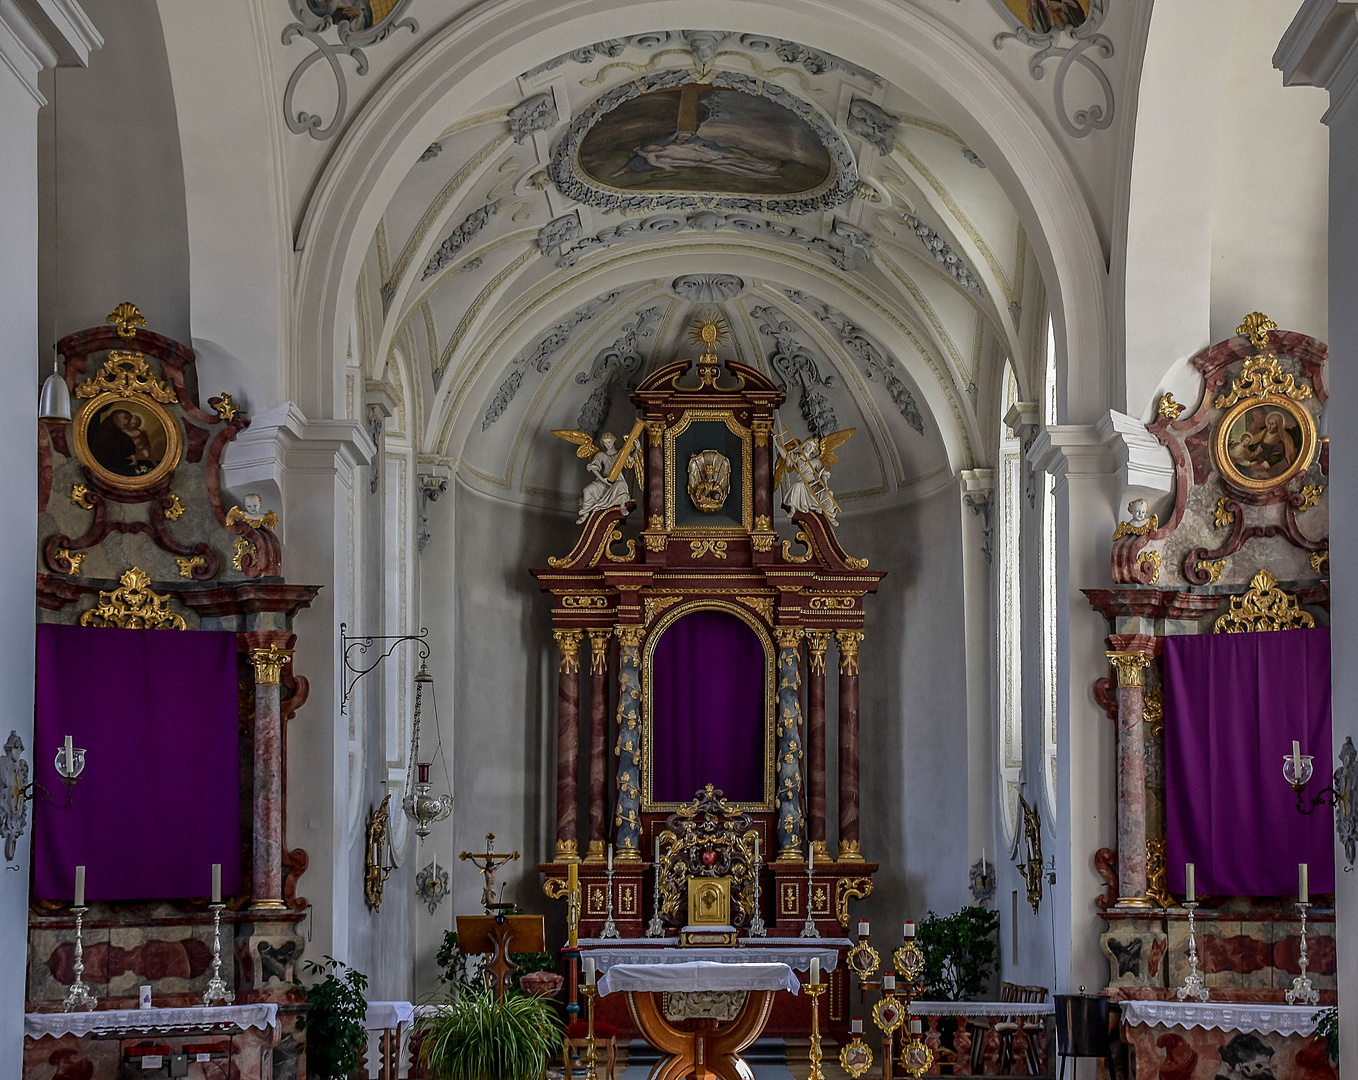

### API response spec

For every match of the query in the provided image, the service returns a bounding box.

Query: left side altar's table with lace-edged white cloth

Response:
[23,1004,278,1080]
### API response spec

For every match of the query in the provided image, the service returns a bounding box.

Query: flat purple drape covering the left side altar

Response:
[33,625,242,901]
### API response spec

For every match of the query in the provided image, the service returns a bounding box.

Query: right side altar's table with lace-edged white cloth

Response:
[1119,1000,1336,1080]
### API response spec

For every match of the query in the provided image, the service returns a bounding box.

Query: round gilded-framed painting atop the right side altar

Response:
[1211,394,1319,494]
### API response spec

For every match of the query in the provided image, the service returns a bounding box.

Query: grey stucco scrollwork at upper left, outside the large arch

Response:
[282,0,420,141]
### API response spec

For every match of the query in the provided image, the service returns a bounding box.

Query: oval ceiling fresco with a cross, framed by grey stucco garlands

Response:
[580,83,831,196]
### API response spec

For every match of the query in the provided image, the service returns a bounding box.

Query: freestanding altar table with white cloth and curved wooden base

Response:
[599,950,800,1080]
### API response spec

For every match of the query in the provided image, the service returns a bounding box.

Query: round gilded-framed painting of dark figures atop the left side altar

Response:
[72,390,183,492]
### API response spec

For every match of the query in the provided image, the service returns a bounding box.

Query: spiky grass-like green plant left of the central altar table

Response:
[414,986,562,1080]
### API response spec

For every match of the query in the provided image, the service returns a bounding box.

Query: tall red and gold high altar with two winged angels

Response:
[532,321,884,1034]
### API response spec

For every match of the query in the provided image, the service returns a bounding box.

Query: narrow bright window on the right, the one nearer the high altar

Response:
[995,365,1024,840]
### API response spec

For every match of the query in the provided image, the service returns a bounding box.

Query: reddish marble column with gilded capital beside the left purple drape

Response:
[250,643,292,910]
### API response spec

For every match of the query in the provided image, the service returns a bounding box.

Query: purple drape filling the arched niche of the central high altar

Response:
[650,611,769,803]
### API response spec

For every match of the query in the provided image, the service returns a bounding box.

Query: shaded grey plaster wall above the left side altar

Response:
[37,0,191,347]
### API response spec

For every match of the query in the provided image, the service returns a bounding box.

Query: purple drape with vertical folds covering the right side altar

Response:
[1164,628,1335,897]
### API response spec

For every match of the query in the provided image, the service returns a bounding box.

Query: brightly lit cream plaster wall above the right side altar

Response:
[1211,0,1329,343]
